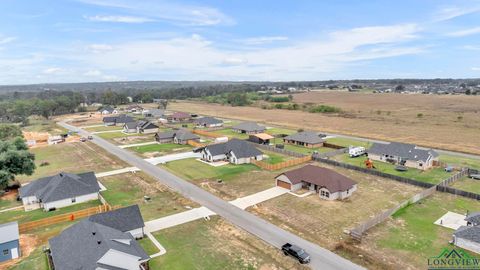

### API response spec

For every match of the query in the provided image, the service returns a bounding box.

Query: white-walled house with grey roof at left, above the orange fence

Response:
[19,172,100,211]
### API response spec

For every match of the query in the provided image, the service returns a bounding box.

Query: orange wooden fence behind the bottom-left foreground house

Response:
[18,204,119,233]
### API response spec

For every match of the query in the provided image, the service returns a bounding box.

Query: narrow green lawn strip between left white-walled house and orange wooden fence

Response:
[0,200,101,224]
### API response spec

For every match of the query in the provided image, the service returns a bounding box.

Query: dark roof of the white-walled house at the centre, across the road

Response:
[205,139,263,158]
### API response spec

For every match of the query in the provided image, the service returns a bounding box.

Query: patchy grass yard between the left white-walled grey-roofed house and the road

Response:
[100,172,198,221]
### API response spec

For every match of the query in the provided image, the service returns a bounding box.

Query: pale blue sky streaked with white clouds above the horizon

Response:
[0,0,480,85]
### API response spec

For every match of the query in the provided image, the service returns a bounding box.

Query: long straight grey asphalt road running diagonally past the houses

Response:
[58,122,363,270]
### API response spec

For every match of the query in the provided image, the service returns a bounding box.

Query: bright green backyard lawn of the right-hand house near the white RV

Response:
[336,154,453,184]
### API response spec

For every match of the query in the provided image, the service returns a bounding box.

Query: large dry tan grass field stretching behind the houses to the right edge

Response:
[169,91,480,154]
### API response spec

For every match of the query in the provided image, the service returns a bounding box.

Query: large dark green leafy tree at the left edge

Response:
[0,137,35,189]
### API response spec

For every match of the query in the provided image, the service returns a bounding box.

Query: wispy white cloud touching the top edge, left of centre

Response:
[78,0,234,26]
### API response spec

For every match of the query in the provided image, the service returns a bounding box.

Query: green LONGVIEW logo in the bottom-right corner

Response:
[428,248,480,270]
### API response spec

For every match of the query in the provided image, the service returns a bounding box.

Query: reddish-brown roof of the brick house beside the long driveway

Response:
[277,165,357,193]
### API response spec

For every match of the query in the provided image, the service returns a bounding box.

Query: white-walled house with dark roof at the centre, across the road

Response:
[202,139,263,164]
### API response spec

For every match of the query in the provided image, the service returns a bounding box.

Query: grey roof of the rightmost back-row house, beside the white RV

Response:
[367,142,438,162]
